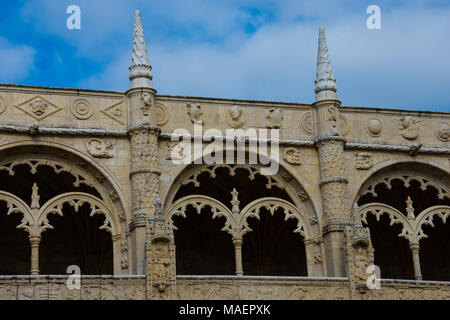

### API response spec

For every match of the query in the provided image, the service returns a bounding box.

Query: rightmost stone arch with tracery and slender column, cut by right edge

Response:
[353,161,450,280]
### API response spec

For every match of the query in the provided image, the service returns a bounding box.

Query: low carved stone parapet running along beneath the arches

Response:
[0,276,450,300]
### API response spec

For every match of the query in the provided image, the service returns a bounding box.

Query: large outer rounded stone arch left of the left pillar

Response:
[0,140,131,274]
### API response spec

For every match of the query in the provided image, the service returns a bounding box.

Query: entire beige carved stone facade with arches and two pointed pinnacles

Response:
[0,10,450,300]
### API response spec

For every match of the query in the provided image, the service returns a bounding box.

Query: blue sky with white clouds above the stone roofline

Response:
[0,0,450,112]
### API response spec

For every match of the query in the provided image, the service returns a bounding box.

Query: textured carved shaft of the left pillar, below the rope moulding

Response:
[130,126,161,218]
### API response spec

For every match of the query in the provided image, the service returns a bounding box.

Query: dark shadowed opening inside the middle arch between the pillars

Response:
[168,167,307,276]
